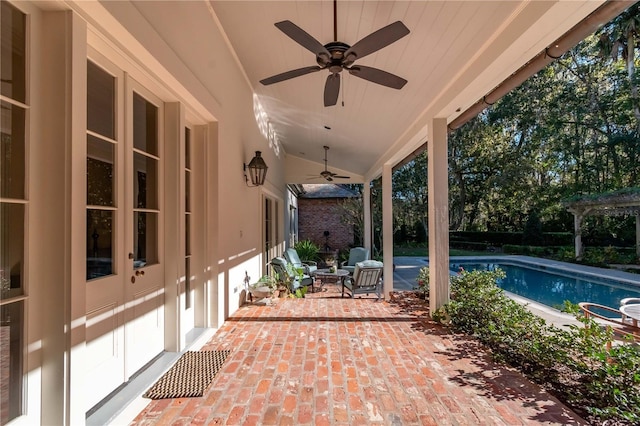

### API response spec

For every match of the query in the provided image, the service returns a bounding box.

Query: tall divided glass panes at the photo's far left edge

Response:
[0,1,29,425]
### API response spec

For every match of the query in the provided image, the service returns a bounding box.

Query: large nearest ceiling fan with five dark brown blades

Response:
[260,0,409,107]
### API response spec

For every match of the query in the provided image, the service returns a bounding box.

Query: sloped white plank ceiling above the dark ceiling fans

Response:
[137,0,602,183]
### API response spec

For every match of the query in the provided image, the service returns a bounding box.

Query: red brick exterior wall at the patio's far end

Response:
[298,198,354,250]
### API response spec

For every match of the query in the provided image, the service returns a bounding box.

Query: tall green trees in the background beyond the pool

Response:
[393,20,640,241]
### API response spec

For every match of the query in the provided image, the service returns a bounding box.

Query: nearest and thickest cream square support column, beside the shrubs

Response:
[427,118,449,314]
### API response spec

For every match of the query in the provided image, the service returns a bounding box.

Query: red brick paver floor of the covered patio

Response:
[132,285,587,425]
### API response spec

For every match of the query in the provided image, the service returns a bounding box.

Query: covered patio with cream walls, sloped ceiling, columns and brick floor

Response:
[0,0,635,425]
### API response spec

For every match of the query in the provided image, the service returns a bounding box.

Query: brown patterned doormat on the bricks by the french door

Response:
[142,350,231,399]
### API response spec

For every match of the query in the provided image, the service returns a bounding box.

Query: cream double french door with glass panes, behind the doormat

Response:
[86,55,164,409]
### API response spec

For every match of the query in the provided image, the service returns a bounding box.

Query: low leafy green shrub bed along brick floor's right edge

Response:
[434,270,640,424]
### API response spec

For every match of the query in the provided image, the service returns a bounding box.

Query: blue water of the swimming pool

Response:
[450,262,640,308]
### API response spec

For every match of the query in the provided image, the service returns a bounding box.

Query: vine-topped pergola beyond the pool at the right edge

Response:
[563,188,640,260]
